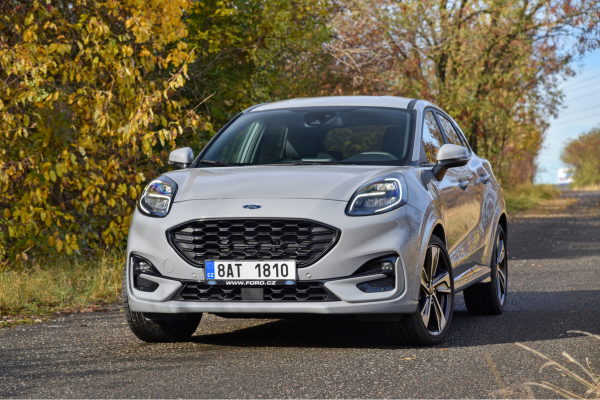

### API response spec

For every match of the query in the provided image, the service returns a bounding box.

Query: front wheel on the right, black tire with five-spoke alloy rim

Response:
[386,235,454,346]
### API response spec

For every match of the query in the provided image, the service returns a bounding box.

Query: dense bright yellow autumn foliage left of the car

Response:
[0,0,212,262]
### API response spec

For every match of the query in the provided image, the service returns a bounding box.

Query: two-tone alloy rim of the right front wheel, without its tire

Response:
[419,245,452,336]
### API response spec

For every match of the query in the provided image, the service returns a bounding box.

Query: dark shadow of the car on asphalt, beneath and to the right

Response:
[191,291,600,348]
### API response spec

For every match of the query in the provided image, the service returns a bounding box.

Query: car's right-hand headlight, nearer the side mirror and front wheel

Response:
[346,174,407,216]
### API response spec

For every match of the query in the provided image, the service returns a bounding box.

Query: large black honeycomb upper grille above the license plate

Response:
[167,219,339,268]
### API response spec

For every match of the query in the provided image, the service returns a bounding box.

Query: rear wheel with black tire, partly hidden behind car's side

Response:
[464,224,508,315]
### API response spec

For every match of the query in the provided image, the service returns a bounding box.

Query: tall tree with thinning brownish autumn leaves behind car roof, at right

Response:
[325,0,600,184]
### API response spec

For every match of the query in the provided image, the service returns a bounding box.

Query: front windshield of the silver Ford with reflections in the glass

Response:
[198,107,413,166]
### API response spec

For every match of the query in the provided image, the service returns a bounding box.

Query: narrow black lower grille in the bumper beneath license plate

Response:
[174,282,339,301]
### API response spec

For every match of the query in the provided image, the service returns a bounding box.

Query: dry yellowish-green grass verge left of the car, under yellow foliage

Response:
[0,251,125,327]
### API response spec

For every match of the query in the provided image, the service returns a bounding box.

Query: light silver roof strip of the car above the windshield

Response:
[247,96,414,112]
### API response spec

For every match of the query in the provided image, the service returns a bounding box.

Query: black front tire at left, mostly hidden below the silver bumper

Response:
[121,269,202,343]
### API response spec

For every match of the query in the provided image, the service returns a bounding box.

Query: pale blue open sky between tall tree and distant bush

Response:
[535,50,600,184]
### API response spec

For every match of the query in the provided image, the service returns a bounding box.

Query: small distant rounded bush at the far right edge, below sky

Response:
[560,126,600,187]
